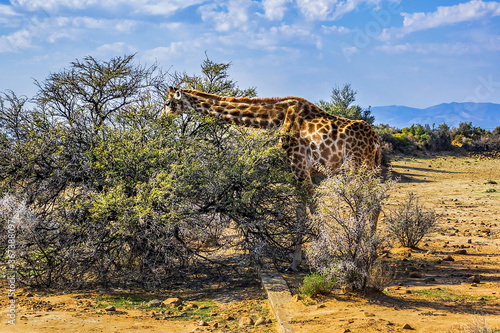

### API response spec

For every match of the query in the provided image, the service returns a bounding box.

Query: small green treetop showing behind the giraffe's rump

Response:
[318,84,375,125]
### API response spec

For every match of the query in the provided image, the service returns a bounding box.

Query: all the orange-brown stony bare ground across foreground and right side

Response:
[0,152,500,333]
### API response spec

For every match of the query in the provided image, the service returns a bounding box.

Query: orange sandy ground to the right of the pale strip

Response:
[288,156,500,332]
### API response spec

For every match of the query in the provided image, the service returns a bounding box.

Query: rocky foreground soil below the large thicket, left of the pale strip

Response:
[0,287,276,333]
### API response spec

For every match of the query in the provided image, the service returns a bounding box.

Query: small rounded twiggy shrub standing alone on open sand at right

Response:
[387,192,436,248]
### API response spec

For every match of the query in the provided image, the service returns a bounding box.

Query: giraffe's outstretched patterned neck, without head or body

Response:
[183,89,292,129]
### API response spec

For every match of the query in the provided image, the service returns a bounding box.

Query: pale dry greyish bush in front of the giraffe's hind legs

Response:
[306,162,395,290]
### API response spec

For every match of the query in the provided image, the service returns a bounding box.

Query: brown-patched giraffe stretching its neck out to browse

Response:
[162,87,382,269]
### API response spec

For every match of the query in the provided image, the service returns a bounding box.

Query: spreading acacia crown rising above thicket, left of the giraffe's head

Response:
[35,55,165,132]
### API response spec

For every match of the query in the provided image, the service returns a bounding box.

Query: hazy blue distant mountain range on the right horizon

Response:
[371,103,500,130]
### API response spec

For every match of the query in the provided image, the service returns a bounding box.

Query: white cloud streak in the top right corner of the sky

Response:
[401,0,500,33]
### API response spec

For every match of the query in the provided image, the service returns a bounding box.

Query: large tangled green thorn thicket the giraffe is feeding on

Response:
[0,56,308,287]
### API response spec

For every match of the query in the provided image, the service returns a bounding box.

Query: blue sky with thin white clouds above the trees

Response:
[0,0,500,107]
